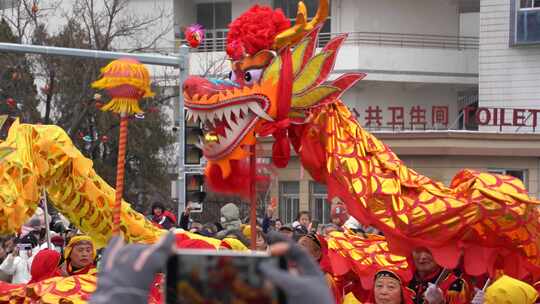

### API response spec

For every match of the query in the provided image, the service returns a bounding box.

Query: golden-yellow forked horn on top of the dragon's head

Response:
[273,0,329,50]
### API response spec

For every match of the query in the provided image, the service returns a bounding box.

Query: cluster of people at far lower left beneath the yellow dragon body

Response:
[0,208,98,284]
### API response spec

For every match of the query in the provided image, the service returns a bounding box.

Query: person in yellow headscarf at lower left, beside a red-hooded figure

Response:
[58,235,97,277]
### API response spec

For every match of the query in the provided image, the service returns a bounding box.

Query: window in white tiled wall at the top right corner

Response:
[510,0,540,45]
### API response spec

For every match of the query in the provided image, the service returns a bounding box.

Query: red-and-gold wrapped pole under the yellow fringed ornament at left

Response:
[112,113,129,235]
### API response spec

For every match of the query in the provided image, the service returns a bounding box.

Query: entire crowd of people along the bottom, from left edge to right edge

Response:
[0,200,538,304]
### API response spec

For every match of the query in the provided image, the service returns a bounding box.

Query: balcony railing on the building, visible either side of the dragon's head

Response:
[177,30,478,52]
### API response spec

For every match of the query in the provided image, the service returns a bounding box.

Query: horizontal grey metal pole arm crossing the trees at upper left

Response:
[0,42,181,67]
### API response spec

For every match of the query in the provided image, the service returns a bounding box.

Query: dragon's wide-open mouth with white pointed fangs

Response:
[186,95,272,160]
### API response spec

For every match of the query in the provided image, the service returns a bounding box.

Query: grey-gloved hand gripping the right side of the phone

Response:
[260,233,334,304]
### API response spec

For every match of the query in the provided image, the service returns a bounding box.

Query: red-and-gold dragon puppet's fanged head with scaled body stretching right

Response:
[184,0,540,278]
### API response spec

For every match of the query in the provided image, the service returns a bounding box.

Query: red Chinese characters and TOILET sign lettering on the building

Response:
[352,105,540,130]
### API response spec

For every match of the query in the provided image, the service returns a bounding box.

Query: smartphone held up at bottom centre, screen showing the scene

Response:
[165,250,286,304]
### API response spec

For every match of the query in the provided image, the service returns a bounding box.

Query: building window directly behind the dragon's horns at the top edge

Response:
[274,0,332,47]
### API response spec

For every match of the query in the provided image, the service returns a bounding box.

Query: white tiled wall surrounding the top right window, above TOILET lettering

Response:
[479,0,540,131]
